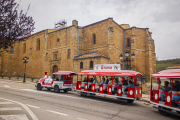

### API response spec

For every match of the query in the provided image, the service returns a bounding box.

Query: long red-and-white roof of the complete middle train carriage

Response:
[77,70,142,76]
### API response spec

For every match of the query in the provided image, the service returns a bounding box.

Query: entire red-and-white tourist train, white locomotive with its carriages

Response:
[35,64,180,116]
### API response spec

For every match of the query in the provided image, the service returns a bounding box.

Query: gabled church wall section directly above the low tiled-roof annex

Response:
[80,20,109,56]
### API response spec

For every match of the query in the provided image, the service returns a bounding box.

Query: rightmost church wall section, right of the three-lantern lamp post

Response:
[125,27,156,80]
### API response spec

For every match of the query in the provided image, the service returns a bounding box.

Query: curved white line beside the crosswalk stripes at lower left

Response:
[0,97,39,120]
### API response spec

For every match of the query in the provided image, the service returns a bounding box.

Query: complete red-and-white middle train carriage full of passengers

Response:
[76,70,142,103]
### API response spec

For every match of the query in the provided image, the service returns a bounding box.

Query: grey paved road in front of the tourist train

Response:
[0,79,178,120]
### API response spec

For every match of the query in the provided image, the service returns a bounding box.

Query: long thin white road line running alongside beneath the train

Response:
[21,89,108,103]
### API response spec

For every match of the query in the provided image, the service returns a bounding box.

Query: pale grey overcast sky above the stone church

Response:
[16,0,180,60]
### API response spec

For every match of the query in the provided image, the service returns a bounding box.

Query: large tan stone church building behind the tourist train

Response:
[0,18,156,79]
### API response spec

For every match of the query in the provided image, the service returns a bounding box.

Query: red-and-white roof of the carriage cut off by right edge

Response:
[151,69,180,78]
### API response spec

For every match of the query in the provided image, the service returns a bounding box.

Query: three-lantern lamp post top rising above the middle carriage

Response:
[119,51,135,70]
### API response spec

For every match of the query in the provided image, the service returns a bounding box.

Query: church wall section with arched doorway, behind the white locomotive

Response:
[44,26,78,74]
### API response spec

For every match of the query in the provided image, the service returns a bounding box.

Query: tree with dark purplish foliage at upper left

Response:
[0,0,35,54]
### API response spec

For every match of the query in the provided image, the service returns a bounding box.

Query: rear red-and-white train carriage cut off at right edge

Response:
[150,69,180,116]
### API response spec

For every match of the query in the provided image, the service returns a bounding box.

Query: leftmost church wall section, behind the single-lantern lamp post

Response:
[1,31,45,77]
